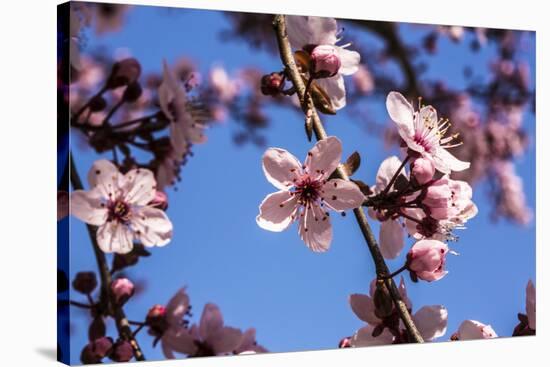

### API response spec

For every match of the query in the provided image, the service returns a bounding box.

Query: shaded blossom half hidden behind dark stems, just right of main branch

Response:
[369,156,405,259]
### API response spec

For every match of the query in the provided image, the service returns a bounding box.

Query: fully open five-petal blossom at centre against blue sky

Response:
[256,137,365,252]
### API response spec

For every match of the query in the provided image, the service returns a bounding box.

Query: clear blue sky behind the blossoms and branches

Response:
[67,7,535,363]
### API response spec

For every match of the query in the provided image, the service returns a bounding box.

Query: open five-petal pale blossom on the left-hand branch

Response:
[70,159,172,254]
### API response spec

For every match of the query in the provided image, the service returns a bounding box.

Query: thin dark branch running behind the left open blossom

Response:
[69,153,145,361]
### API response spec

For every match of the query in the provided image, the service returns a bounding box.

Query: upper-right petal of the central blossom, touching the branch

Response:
[305,136,342,180]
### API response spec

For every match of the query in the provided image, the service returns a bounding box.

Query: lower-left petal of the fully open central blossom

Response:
[256,190,298,232]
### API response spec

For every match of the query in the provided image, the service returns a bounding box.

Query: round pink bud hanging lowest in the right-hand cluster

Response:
[407,240,449,282]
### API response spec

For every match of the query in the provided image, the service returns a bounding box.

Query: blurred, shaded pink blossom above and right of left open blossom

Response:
[158,61,206,156]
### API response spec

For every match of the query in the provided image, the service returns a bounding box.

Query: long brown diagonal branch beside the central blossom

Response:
[273,15,424,343]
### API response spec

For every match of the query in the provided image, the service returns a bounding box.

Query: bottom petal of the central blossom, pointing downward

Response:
[298,204,332,252]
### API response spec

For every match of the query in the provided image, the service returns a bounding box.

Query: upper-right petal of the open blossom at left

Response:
[123,168,157,205]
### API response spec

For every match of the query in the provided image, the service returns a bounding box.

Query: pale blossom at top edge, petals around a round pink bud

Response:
[285,15,361,110]
